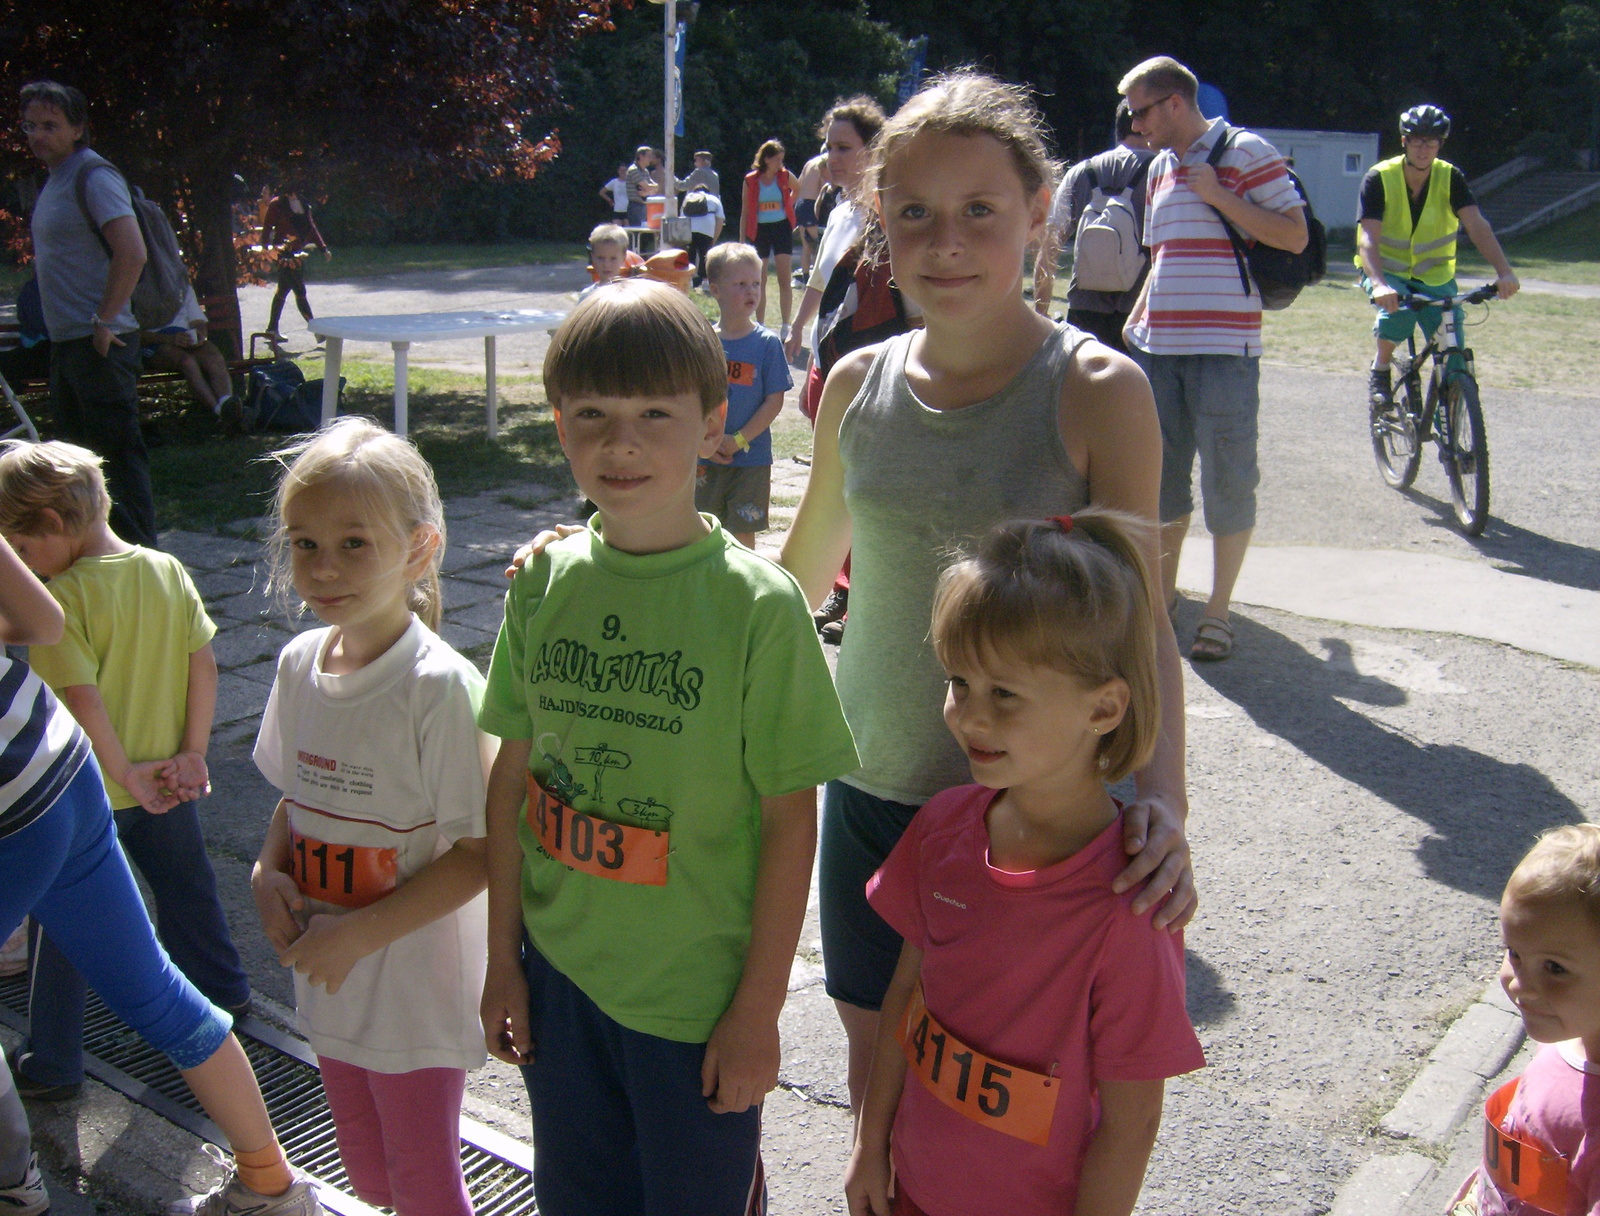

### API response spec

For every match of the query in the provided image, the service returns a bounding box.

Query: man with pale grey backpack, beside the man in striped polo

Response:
[1034,99,1155,354]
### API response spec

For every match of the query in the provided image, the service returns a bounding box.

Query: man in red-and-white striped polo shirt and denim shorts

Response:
[1117,56,1307,659]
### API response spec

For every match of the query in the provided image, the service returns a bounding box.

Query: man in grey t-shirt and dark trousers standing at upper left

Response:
[22,80,155,547]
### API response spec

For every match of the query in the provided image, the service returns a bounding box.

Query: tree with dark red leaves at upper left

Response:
[0,0,617,348]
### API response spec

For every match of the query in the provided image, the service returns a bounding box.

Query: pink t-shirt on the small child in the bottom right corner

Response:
[1478,1043,1600,1216]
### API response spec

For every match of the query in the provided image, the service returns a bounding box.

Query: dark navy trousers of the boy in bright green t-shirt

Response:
[522,941,766,1216]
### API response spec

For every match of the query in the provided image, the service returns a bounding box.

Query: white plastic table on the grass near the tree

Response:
[307,309,566,440]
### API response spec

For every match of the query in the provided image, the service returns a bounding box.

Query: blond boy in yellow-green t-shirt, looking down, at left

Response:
[0,440,250,1098]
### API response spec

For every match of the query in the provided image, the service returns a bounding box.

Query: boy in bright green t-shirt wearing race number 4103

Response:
[478,283,858,1216]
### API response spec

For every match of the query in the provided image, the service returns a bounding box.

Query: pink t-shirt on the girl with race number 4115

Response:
[867,786,1205,1216]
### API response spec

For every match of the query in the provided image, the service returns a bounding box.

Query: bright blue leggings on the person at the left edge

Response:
[0,758,234,1069]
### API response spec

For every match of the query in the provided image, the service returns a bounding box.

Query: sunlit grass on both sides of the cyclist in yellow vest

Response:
[1262,278,1600,397]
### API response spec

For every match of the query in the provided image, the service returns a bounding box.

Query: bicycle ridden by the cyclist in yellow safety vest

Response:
[1368,283,1498,536]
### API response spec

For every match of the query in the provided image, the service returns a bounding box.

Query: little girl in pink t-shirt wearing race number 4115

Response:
[845,509,1205,1216]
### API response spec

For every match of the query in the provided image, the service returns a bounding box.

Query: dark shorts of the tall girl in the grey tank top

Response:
[818,781,920,1010]
